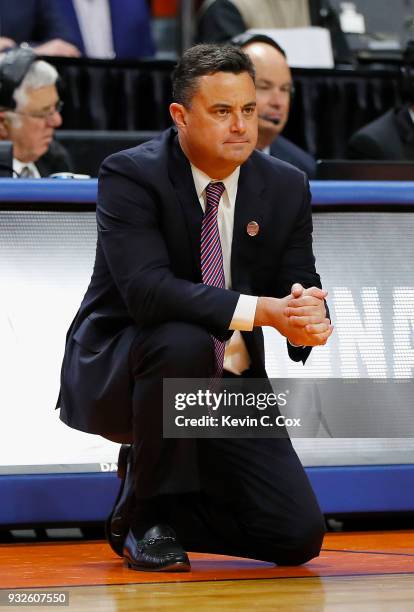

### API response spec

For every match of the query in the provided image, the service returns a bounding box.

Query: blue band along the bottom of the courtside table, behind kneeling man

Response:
[0,465,414,526]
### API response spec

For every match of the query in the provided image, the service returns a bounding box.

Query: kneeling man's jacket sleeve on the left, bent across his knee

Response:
[97,152,240,339]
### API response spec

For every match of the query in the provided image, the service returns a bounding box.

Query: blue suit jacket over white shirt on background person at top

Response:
[59,0,155,59]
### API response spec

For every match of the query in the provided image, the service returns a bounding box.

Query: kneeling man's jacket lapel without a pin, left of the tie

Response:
[168,135,203,279]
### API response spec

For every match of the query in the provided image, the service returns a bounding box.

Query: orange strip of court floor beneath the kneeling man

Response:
[0,531,414,589]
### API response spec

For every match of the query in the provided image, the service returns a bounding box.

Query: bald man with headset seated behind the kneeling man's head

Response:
[232,32,316,179]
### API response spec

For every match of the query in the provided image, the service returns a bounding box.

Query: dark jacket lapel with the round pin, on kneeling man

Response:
[231,153,266,293]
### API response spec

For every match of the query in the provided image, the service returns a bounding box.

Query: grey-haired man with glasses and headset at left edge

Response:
[0,49,71,178]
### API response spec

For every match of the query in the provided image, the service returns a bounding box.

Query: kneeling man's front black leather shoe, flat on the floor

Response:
[124,525,191,572]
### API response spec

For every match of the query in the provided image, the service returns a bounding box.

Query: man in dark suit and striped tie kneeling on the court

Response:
[59,45,332,571]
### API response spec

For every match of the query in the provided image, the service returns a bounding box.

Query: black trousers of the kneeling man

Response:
[130,322,325,565]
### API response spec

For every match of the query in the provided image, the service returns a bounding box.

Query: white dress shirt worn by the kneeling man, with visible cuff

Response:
[191,164,258,374]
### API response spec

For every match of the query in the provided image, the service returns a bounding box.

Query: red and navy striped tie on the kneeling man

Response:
[201,182,226,377]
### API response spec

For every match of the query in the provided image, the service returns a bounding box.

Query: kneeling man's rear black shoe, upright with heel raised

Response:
[105,444,135,557]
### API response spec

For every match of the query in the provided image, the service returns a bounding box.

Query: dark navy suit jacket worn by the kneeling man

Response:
[58,128,320,437]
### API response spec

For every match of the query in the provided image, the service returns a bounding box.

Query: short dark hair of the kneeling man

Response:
[172,44,255,107]
